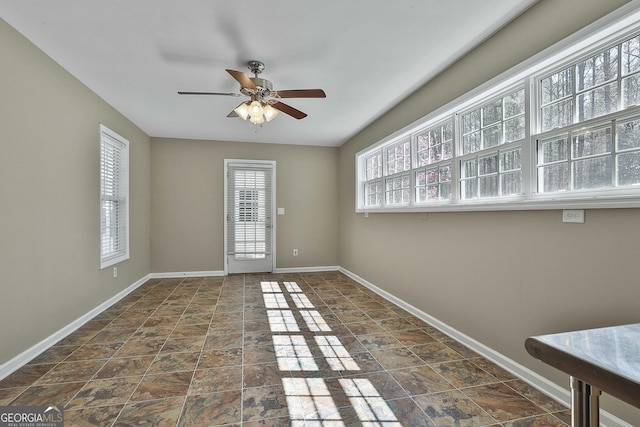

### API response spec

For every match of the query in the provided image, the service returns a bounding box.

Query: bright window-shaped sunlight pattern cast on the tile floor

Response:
[268,282,402,427]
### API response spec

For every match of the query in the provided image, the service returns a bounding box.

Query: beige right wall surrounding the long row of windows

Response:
[339,0,640,425]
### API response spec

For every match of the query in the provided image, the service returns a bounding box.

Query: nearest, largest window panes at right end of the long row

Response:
[536,32,640,193]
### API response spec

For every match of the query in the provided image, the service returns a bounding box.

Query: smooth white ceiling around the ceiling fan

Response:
[0,0,536,146]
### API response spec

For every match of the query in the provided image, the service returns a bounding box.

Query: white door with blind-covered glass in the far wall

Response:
[225,160,275,274]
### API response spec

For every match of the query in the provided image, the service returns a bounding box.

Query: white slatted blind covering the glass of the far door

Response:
[227,164,273,259]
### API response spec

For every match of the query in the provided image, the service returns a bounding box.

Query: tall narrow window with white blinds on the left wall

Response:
[100,125,129,268]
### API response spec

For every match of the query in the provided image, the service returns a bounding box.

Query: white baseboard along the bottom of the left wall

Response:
[0,275,151,380]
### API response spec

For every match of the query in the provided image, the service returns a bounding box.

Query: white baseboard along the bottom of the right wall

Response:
[339,267,633,427]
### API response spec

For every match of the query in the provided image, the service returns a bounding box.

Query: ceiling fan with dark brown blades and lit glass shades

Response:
[178,61,327,124]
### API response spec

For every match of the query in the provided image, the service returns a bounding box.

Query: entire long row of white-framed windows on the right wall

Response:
[356,7,640,211]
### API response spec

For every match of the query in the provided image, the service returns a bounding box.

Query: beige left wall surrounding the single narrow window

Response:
[0,19,150,366]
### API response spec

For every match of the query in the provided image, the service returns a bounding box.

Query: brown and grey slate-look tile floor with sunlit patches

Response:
[0,272,570,427]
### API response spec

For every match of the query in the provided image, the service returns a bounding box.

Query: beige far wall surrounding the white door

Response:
[151,138,338,273]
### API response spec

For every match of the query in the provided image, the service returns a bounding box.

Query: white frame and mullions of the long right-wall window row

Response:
[355,0,640,213]
